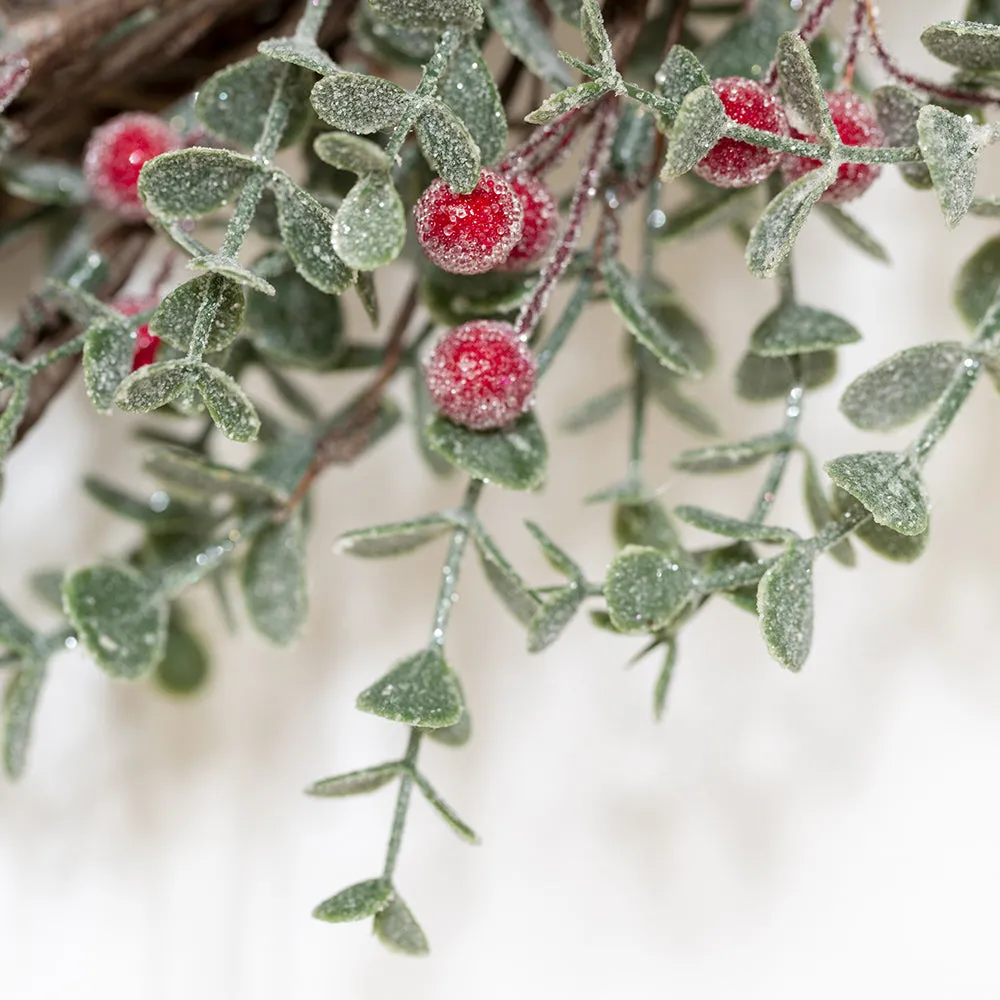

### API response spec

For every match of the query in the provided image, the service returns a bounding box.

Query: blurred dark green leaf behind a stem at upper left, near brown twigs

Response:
[194,55,313,149]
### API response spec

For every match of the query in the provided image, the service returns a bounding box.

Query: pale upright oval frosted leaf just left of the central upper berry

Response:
[333,172,404,271]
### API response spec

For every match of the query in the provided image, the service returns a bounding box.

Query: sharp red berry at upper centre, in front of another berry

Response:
[413,170,524,274]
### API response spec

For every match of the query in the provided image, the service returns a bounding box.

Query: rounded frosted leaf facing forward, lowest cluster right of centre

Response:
[604,545,693,632]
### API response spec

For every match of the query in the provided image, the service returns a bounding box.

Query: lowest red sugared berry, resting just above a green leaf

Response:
[424,319,538,431]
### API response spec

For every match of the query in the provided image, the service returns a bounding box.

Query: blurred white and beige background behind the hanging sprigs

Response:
[0,0,1000,1000]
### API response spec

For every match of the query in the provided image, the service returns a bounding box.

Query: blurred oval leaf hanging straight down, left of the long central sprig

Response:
[243,516,309,646]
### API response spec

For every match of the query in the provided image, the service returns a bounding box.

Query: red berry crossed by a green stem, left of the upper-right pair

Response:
[694,76,788,187]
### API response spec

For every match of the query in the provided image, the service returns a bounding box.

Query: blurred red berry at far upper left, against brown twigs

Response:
[83,111,182,219]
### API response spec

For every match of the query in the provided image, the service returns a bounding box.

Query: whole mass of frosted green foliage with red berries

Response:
[0,0,1000,954]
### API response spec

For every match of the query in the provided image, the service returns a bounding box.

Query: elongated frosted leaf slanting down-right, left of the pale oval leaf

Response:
[272,172,354,295]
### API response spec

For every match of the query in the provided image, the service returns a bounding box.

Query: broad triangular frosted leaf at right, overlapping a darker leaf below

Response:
[824,451,930,535]
